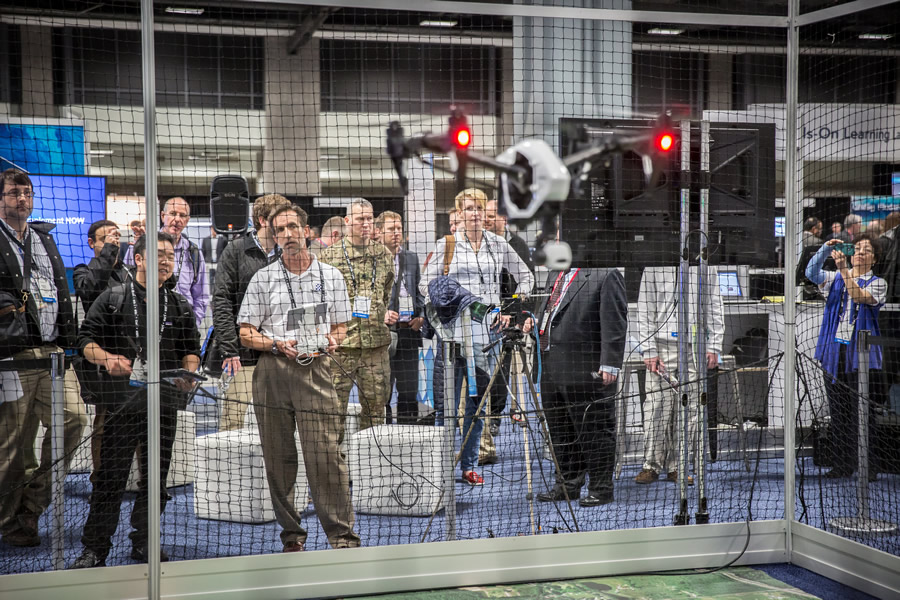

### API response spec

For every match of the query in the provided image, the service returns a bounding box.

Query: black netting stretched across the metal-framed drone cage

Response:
[0,2,900,574]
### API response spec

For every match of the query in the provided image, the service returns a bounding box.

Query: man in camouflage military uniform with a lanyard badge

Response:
[319,198,394,438]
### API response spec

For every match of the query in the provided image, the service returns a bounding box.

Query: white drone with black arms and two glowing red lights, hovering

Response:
[387,106,677,270]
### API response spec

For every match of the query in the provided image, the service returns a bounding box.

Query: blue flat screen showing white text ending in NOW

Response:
[28,175,106,269]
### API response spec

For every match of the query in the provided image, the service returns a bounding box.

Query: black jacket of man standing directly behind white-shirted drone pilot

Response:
[212,235,273,365]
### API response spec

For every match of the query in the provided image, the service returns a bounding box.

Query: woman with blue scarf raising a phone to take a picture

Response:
[806,233,887,480]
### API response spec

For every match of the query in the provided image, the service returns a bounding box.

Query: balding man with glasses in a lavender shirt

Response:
[125,196,209,327]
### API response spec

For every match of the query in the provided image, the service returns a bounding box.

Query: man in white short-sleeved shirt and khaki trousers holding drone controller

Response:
[238,205,360,552]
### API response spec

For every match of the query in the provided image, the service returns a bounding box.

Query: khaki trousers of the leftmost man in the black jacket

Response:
[0,345,87,533]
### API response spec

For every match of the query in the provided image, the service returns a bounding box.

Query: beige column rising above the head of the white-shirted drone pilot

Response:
[256,37,321,196]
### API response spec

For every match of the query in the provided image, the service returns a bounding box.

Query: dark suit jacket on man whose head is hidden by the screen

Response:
[536,269,628,387]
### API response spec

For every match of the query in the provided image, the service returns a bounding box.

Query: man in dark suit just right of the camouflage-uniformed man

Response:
[375,211,425,425]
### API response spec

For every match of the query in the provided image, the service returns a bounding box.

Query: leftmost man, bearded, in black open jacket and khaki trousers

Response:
[0,169,87,546]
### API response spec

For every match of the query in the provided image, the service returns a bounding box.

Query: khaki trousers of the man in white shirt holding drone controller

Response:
[253,354,360,548]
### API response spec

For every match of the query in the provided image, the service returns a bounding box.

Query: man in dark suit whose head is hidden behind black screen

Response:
[537,269,628,507]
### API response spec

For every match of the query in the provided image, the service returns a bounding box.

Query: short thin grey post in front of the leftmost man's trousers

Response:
[50,352,66,570]
